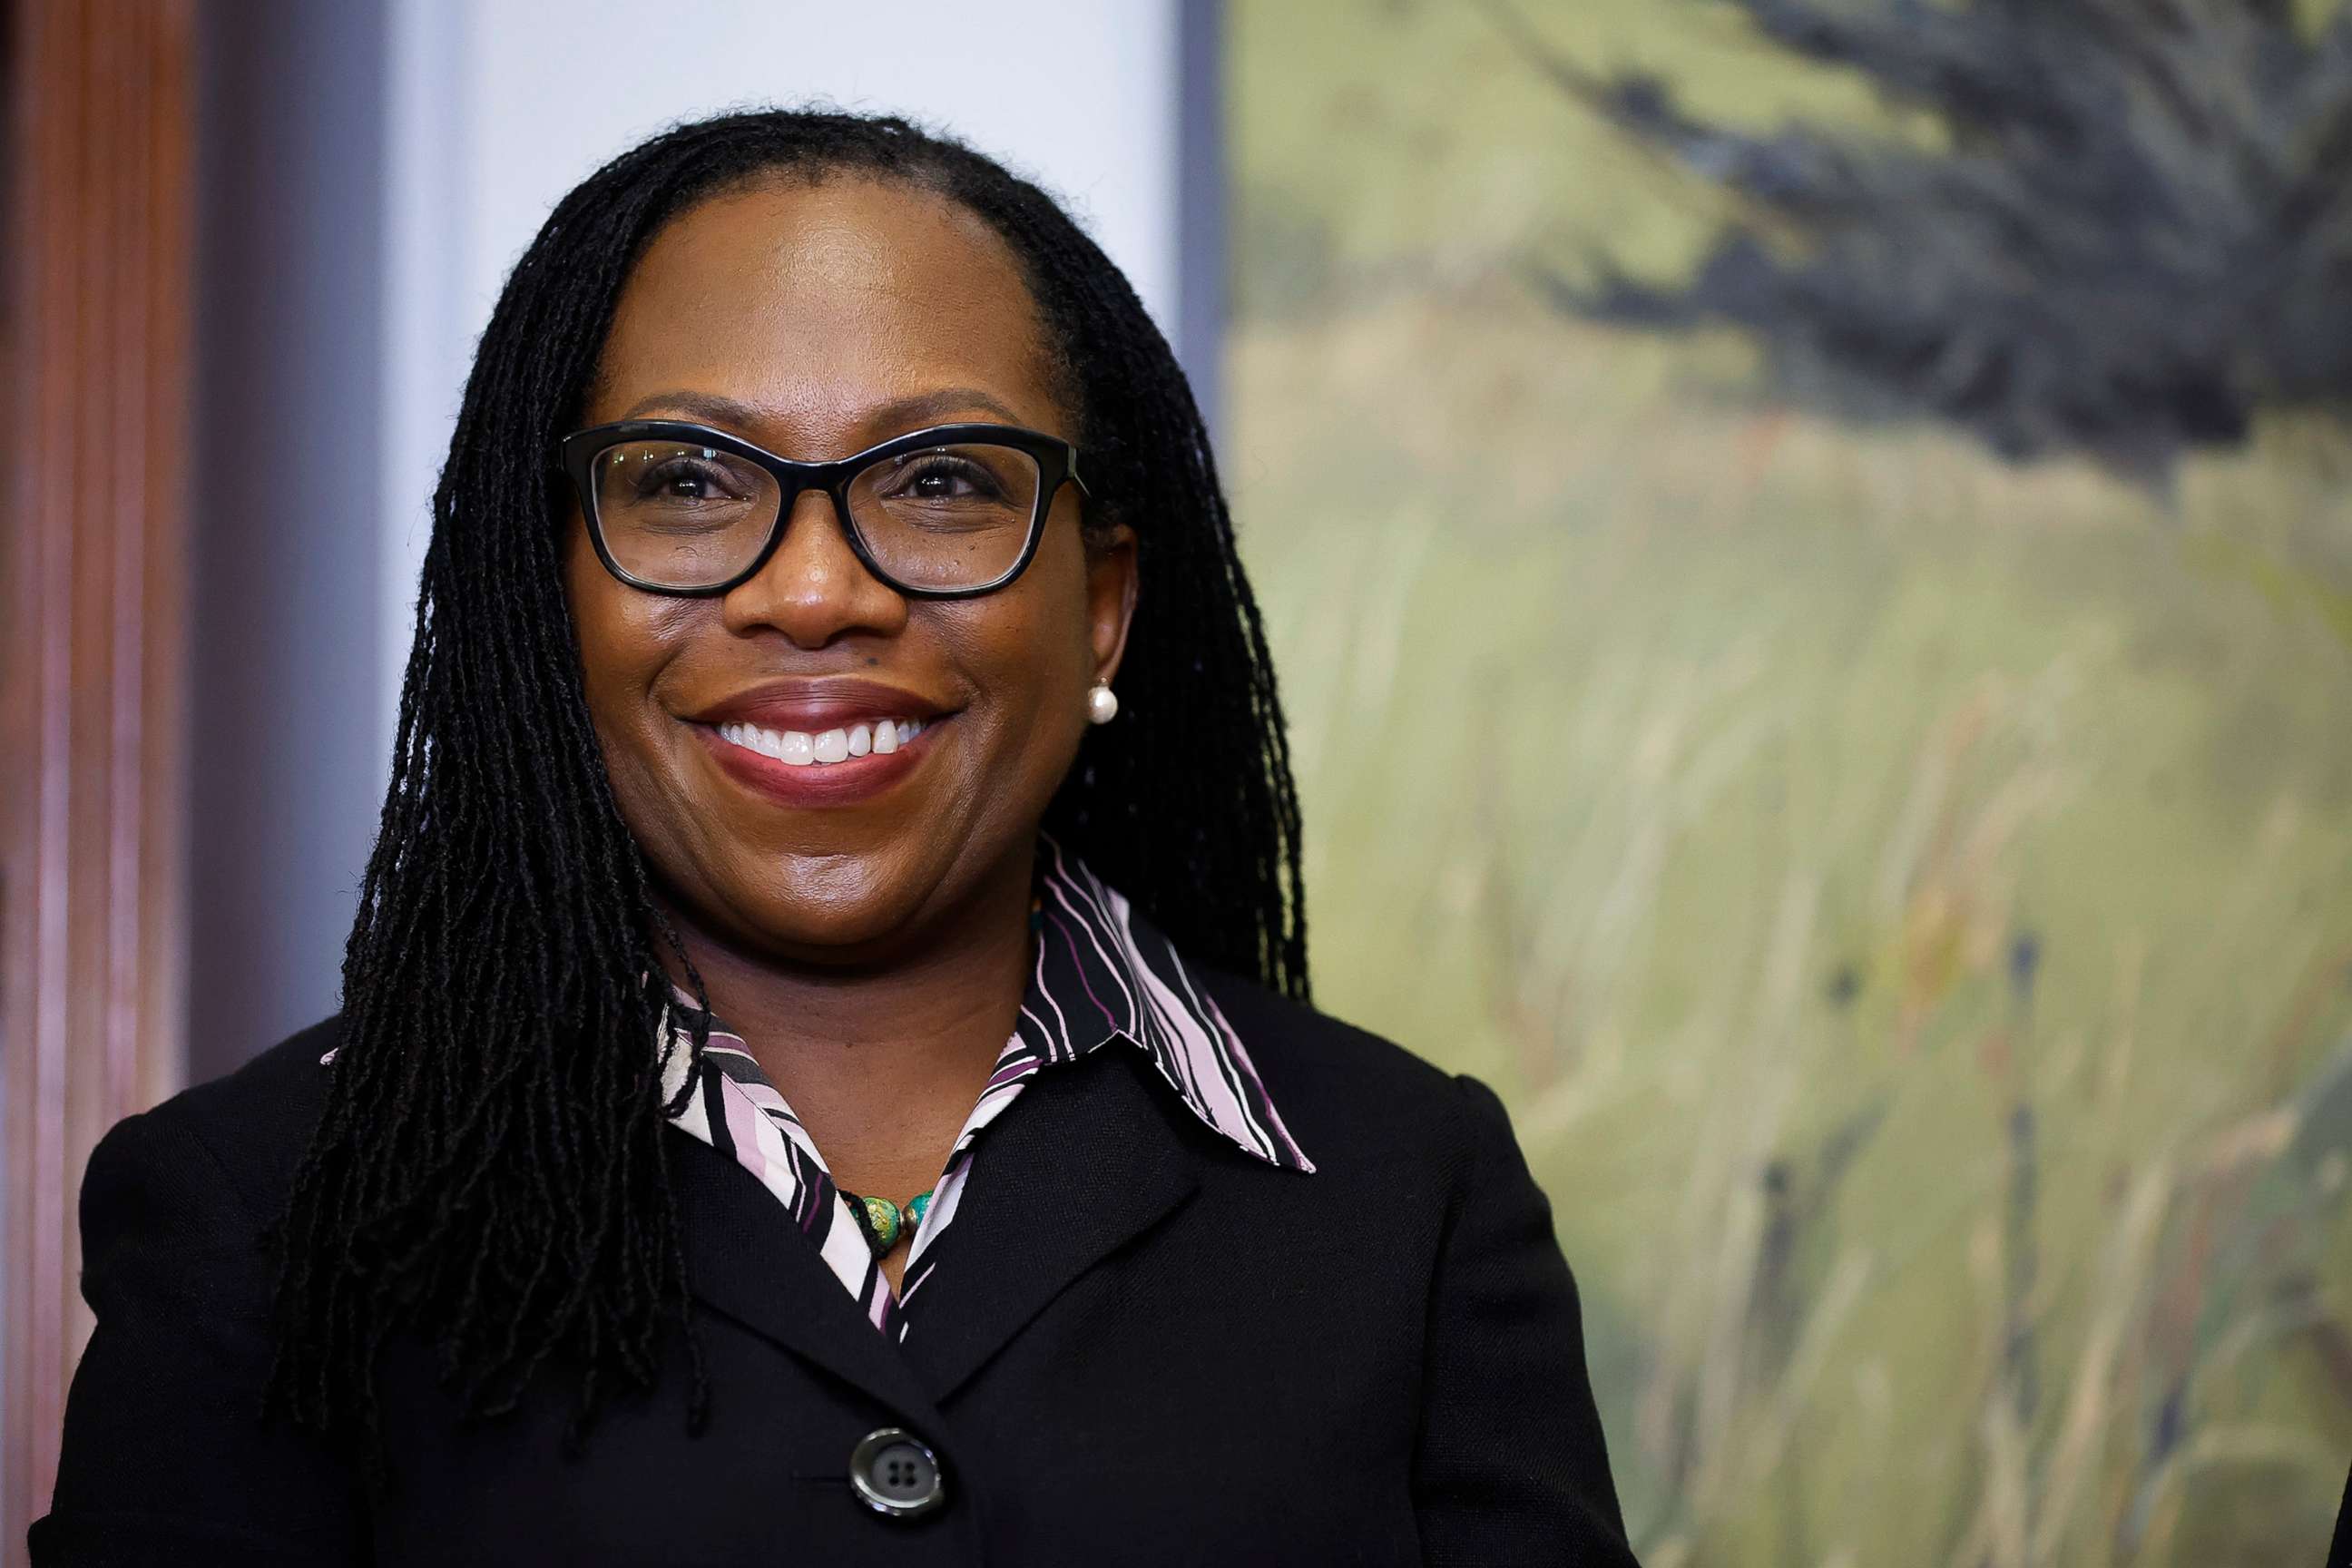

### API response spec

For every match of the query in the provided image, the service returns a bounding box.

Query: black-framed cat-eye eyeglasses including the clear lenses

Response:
[557,418,1087,600]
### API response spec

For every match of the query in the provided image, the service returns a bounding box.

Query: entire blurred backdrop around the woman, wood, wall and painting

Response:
[0,0,2352,1568]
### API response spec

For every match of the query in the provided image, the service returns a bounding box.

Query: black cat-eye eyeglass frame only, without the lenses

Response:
[555,418,1092,600]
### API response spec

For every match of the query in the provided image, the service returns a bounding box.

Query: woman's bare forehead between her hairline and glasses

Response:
[588,176,1068,458]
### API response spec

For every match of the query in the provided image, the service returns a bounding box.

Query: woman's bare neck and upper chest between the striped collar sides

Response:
[671,856,1033,1201]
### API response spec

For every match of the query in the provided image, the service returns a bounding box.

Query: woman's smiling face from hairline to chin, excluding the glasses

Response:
[564,179,1136,964]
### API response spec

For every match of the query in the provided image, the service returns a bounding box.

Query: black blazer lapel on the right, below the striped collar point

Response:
[898,1042,1200,1401]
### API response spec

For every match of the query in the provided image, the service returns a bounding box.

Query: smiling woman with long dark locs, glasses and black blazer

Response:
[33,113,1630,1565]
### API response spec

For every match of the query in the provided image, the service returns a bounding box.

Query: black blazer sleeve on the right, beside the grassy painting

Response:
[1414,1077,1634,1568]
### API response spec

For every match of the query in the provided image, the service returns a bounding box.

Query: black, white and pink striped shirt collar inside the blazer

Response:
[663,839,1315,1338]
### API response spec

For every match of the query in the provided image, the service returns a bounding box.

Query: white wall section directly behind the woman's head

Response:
[392,0,1181,748]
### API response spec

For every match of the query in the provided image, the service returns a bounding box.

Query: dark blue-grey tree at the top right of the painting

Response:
[1494,0,2352,480]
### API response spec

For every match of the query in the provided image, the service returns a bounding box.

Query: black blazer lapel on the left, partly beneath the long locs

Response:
[668,1129,943,1432]
